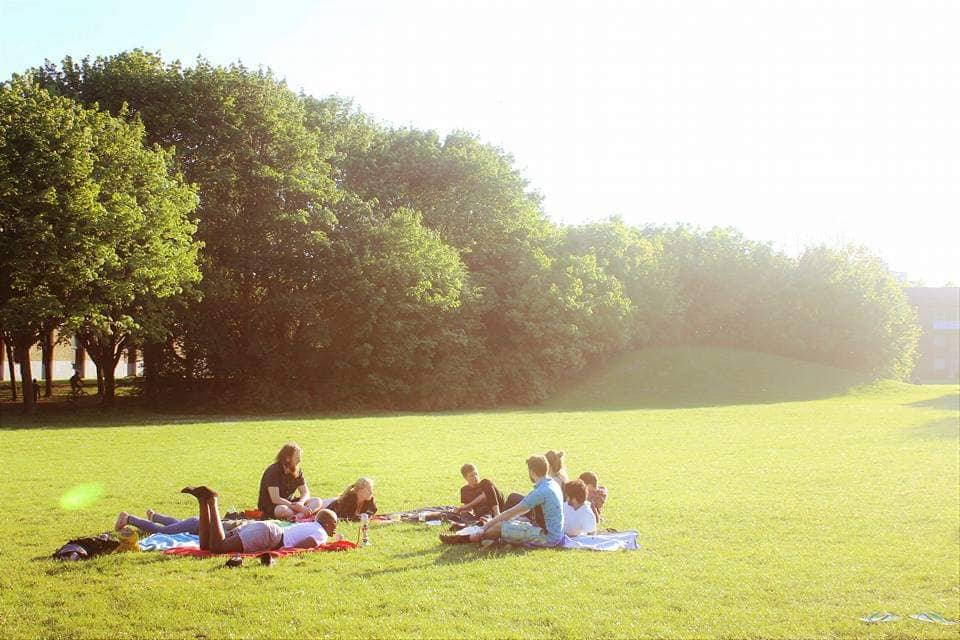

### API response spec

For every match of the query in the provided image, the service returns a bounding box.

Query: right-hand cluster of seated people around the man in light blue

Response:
[440,451,607,547]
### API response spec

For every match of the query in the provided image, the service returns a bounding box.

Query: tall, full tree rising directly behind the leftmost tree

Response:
[35,51,339,400]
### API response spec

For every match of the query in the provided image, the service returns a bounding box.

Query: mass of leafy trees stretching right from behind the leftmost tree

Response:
[13,50,918,408]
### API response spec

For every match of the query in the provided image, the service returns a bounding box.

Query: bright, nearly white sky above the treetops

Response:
[0,0,960,285]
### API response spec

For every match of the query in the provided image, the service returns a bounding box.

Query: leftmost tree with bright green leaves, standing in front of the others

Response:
[0,78,196,410]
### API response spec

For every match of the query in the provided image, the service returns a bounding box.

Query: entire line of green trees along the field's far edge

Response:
[0,50,919,409]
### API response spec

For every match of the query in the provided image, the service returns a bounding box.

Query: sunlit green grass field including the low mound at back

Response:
[0,349,960,639]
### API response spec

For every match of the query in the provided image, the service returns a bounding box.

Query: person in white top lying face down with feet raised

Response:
[181,486,337,553]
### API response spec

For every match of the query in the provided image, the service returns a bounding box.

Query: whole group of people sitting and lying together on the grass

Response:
[115,443,607,553]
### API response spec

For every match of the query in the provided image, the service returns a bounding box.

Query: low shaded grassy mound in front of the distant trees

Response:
[543,347,906,410]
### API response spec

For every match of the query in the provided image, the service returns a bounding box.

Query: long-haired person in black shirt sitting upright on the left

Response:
[257,442,321,520]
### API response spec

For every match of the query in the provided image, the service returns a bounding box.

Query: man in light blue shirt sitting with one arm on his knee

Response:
[470,456,563,547]
